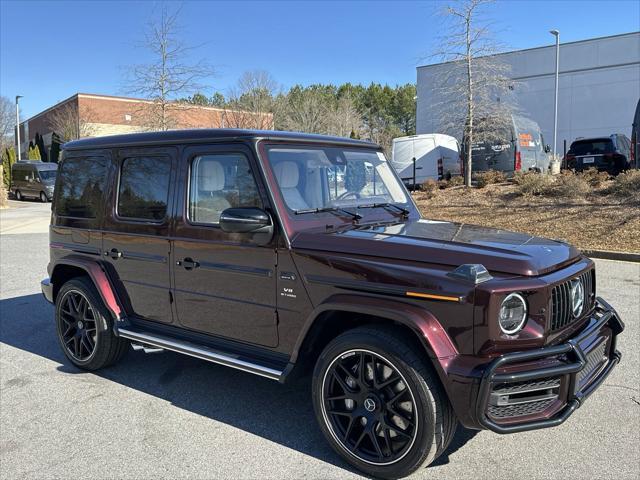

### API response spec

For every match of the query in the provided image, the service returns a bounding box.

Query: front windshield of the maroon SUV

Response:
[267,146,409,213]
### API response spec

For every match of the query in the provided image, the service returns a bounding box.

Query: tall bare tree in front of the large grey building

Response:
[432,0,516,186]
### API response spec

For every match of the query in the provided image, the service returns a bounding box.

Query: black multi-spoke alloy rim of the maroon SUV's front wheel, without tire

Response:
[322,349,419,465]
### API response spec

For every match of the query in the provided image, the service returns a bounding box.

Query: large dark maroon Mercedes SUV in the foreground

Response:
[42,130,623,478]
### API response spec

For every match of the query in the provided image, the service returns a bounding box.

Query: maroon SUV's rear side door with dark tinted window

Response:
[103,147,177,323]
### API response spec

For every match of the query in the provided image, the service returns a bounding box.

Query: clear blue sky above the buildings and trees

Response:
[0,0,640,118]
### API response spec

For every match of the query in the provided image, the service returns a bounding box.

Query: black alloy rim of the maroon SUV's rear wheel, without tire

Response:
[60,290,98,362]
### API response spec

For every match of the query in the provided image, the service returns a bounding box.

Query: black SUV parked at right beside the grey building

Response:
[565,133,634,175]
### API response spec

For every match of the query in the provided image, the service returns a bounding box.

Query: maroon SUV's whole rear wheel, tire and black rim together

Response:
[56,277,129,371]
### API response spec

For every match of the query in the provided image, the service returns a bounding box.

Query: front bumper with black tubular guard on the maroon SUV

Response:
[476,298,624,433]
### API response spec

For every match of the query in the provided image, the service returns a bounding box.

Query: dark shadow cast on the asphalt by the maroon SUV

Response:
[0,294,475,472]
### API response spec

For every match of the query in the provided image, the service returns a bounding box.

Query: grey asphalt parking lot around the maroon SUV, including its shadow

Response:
[0,202,640,479]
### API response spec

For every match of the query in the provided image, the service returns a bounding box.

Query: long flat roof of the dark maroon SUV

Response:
[62,128,380,150]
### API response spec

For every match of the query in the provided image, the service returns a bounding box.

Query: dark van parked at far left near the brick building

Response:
[11,161,58,202]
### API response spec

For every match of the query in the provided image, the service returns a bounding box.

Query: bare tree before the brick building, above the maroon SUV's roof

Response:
[128,5,214,130]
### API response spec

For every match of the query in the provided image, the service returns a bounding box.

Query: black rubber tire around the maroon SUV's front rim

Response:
[312,332,436,478]
